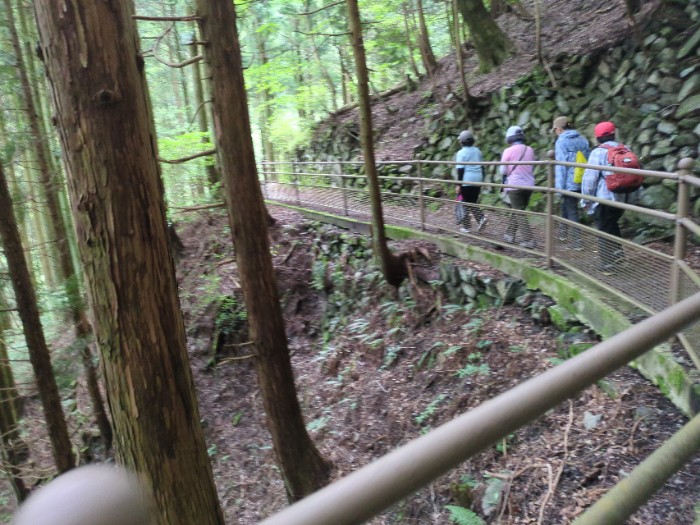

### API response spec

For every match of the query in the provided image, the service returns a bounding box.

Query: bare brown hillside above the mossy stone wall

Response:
[317,0,662,160]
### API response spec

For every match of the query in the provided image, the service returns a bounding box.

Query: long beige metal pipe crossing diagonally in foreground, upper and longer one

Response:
[261,293,700,525]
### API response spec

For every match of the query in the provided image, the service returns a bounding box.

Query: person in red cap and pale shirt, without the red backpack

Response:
[581,122,639,275]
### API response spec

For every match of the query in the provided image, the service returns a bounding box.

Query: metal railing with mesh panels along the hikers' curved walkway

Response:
[260,153,700,369]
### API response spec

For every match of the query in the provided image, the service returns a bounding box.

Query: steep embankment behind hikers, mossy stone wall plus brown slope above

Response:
[305,0,700,221]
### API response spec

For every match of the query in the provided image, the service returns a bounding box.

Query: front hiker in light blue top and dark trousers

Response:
[455,130,486,233]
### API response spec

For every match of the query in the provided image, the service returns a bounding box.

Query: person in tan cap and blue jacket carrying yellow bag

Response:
[552,117,591,250]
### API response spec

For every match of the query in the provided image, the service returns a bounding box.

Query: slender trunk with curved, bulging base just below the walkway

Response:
[346,0,406,285]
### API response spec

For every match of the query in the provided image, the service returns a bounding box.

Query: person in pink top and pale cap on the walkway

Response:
[500,126,535,248]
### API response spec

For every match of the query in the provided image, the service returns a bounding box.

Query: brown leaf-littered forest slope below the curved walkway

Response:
[178,207,700,525]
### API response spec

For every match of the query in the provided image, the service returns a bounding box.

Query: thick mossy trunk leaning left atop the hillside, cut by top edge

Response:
[457,0,513,71]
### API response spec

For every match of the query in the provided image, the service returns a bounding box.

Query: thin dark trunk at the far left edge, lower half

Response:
[0,289,29,503]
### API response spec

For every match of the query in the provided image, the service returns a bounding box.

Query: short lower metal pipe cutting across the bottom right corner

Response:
[573,415,700,525]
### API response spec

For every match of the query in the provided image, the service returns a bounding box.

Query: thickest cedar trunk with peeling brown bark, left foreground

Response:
[35,0,223,525]
